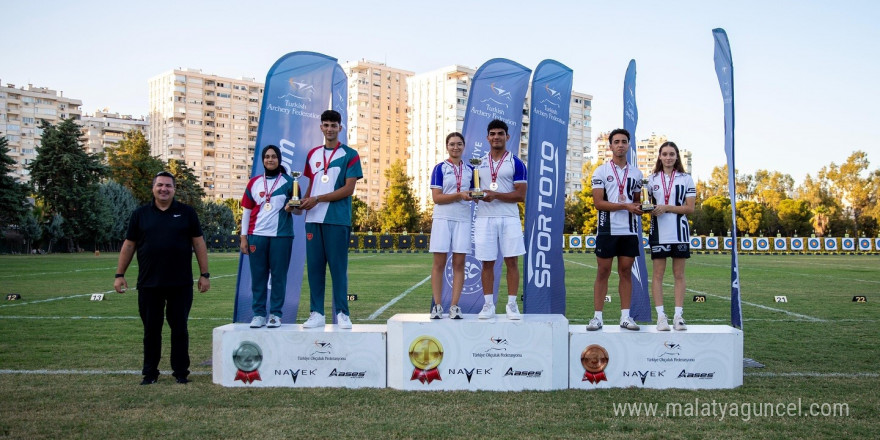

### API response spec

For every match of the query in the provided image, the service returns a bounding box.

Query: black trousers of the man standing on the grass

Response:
[138,284,193,378]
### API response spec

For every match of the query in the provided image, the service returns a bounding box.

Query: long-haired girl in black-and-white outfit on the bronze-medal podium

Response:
[648,142,697,331]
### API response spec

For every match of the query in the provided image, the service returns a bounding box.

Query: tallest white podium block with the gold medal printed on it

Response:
[388,313,569,391]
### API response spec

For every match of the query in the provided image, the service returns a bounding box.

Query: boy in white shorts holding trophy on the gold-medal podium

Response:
[474,119,528,319]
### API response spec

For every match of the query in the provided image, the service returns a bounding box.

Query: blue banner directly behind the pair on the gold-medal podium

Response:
[444,58,532,313]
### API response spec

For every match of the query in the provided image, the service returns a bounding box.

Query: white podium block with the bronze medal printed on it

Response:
[568,322,743,389]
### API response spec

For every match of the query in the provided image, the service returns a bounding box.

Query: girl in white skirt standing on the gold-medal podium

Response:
[430,133,474,319]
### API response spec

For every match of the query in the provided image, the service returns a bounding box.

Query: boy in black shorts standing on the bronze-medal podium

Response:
[587,128,642,330]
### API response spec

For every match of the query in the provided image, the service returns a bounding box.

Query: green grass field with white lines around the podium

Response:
[0,253,880,439]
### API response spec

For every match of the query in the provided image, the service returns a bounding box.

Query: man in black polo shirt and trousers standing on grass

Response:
[113,171,211,385]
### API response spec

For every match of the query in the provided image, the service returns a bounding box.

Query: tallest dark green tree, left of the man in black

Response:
[28,119,107,248]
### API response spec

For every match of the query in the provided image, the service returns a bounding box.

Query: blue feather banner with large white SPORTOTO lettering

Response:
[522,60,574,314]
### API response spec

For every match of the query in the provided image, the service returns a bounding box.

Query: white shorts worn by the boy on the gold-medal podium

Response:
[474,217,526,261]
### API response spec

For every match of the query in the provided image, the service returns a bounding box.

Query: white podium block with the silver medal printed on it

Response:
[213,324,387,388]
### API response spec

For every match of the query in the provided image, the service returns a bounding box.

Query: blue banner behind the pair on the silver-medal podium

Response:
[232,52,347,322]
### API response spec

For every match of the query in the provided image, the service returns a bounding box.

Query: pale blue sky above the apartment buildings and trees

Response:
[0,0,880,182]
